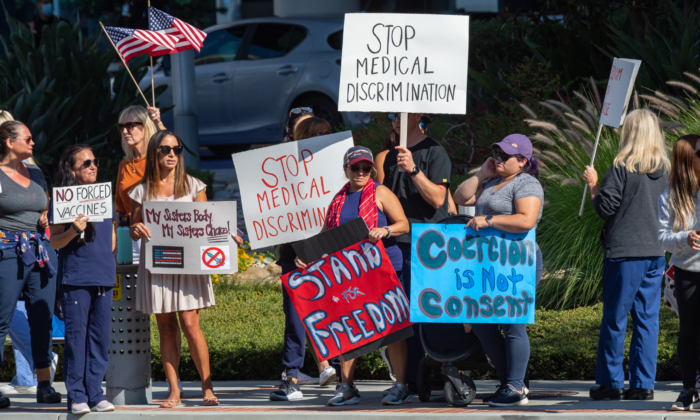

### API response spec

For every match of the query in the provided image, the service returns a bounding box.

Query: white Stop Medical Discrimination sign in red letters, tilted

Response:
[233,131,353,249]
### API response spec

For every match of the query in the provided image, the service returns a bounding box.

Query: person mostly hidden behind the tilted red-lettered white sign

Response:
[270,116,340,401]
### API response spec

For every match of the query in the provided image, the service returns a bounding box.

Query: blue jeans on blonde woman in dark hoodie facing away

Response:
[596,257,660,389]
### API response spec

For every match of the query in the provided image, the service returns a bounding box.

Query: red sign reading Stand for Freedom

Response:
[282,241,411,360]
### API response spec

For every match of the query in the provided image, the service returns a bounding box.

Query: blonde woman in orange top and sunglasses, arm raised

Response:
[114,105,165,264]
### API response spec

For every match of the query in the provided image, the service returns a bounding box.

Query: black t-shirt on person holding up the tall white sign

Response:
[383,137,452,243]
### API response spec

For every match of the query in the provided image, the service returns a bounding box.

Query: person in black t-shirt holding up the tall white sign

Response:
[381,114,452,392]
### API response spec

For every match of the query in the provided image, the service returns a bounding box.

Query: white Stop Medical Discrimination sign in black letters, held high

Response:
[338,13,469,114]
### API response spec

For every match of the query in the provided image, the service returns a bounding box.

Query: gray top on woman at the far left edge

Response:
[0,165,48,233]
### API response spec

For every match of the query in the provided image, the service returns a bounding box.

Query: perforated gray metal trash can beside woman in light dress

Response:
[107,264,153,405]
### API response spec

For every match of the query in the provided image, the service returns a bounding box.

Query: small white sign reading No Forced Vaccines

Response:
[52,182,112,224]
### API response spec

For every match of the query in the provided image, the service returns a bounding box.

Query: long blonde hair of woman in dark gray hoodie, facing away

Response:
[613,109,671,174]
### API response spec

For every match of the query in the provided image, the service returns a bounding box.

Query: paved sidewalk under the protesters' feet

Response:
[0,381,689,420]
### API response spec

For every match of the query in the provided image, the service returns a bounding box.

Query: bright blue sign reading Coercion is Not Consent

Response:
[411,224,537,324]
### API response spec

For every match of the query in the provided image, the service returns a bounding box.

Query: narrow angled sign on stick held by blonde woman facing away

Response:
[600,58,642,128]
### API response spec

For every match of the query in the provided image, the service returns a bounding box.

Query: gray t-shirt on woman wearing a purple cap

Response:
[474,173,544,229]
